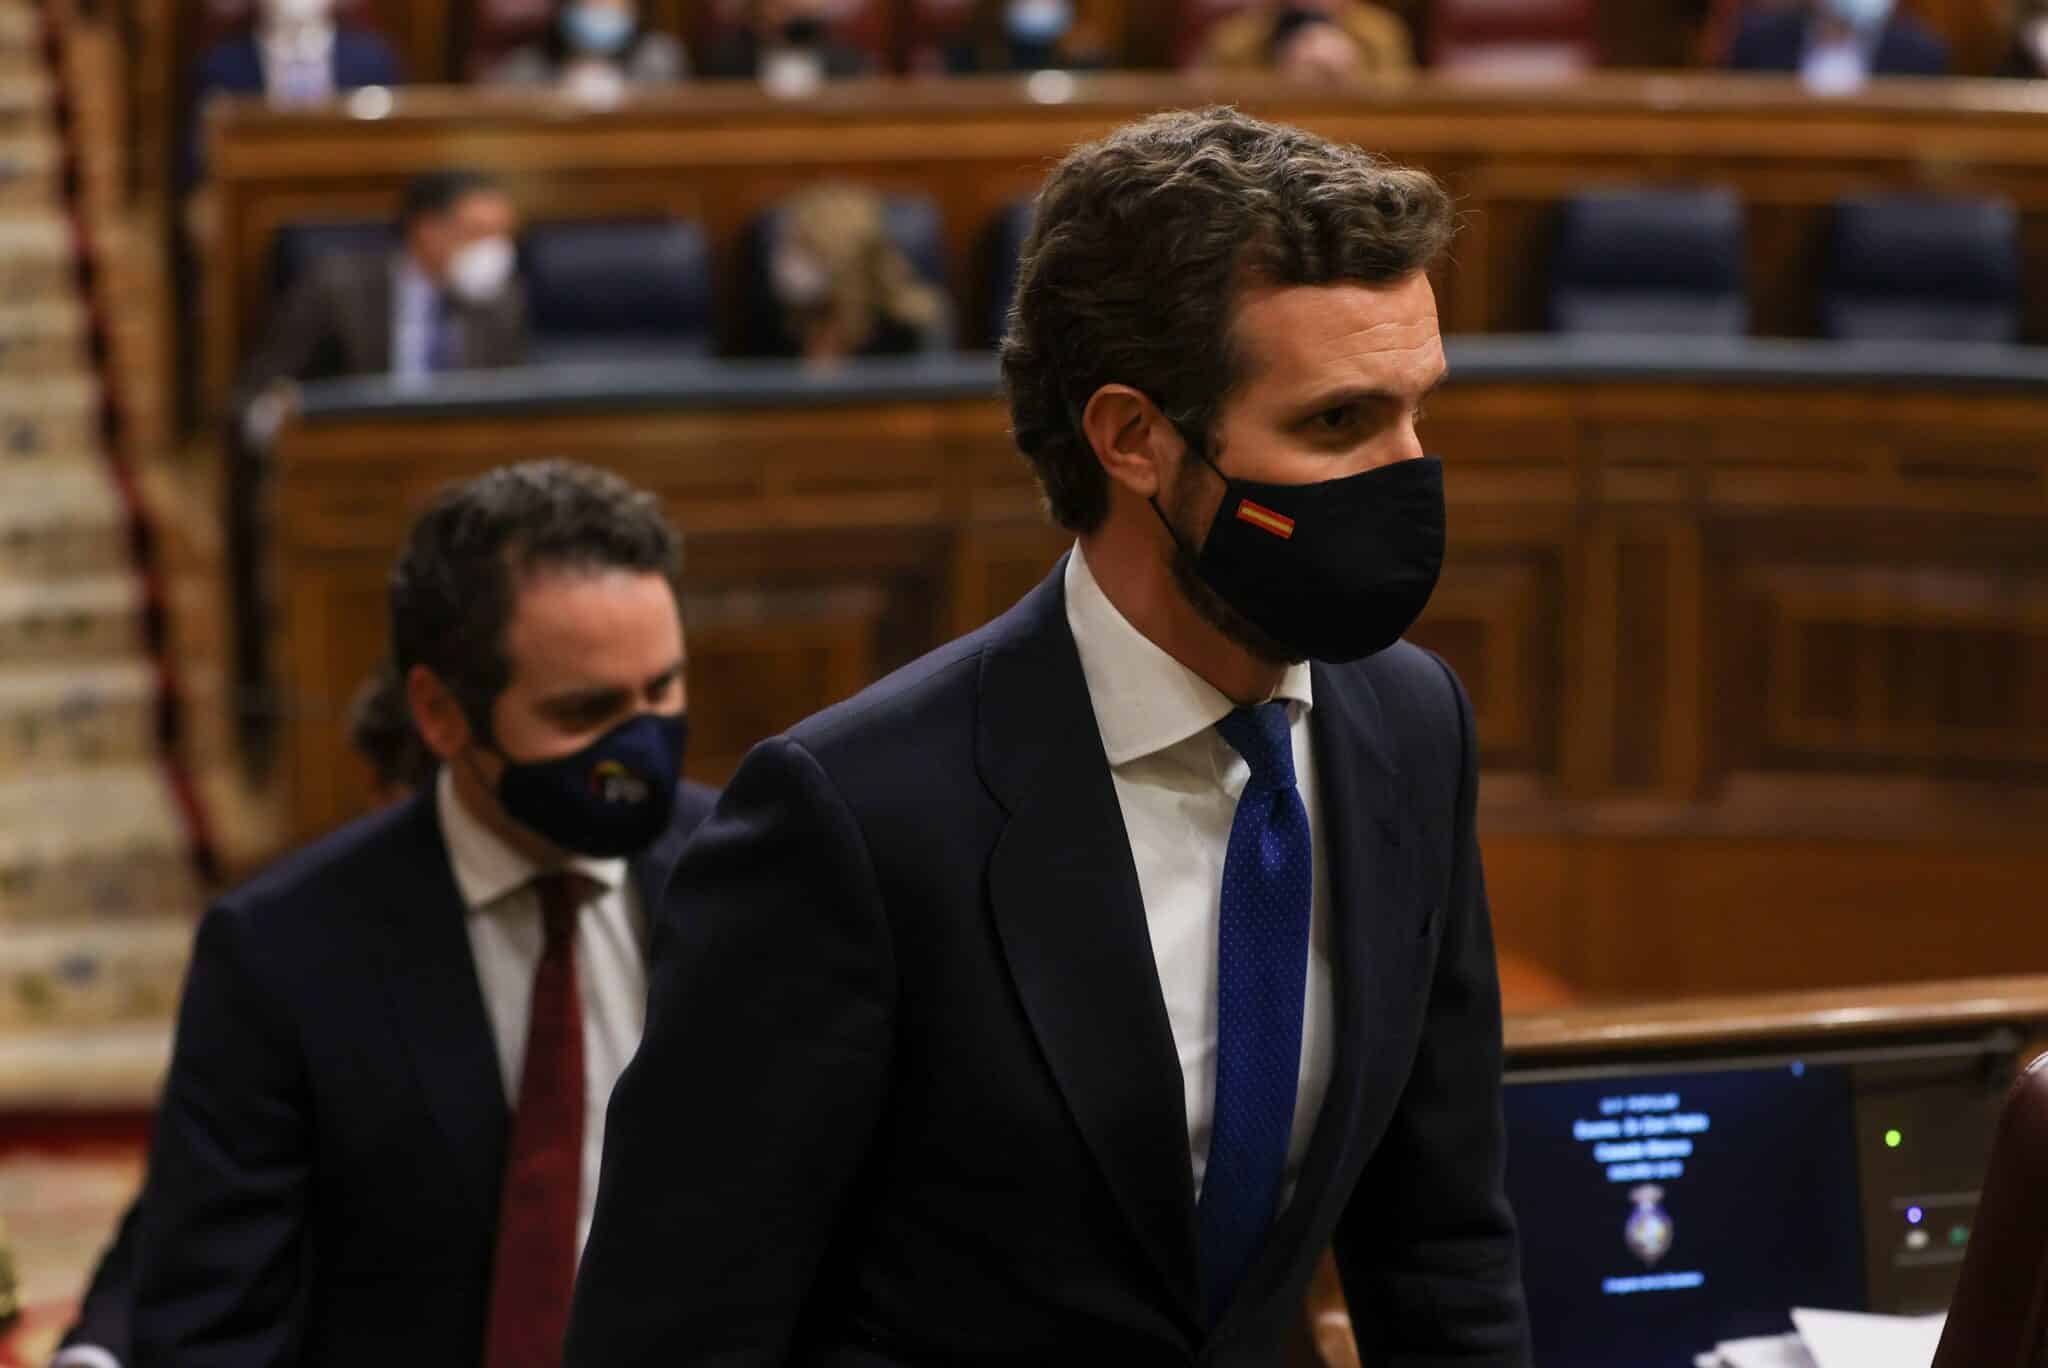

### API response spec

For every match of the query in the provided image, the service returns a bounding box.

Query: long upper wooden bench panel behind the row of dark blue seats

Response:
[207,78,2048,413]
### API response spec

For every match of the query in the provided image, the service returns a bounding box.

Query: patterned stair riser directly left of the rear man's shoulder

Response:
[0,909,193,1036]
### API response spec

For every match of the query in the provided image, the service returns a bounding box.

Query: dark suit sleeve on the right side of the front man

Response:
[1335,661,1530,1368]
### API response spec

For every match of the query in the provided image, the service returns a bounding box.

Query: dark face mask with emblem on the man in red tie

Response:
[498,713,690,860]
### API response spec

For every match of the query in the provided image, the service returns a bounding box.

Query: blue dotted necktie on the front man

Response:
[1194,702,1315,1323]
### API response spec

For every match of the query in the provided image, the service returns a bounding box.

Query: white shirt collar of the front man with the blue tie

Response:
[1065,545,1315,768]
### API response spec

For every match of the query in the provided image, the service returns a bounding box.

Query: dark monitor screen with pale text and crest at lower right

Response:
[1505,1063,1868,1368]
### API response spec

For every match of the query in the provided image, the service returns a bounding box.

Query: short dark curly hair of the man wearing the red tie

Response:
[389,461,682,739]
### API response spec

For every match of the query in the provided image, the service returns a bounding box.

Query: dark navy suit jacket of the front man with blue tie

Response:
[567,557,1530,1368]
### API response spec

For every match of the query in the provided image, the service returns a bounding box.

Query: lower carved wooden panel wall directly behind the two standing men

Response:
[279,374,2048,997]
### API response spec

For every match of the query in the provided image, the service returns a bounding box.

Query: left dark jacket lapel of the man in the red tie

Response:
[372,788,510,1221]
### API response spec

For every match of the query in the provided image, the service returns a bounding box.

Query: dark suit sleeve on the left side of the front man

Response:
[567,739,895,1368]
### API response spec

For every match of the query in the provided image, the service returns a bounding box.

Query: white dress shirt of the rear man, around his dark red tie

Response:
[434,768,647,1251]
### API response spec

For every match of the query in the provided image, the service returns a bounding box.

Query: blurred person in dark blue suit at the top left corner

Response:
[180,0,406,186]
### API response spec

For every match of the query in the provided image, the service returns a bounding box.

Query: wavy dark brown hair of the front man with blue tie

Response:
[1001,109,1456,532]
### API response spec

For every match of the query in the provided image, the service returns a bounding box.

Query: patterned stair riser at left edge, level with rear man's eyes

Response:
[0,659,162,782]
